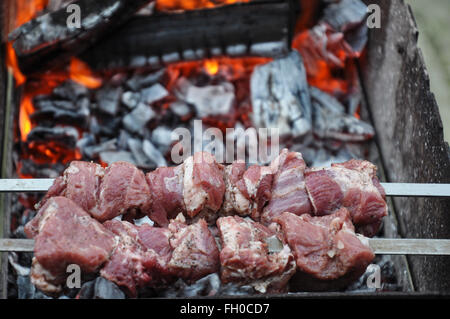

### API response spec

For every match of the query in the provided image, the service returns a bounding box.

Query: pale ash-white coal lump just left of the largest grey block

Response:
[186,82,235,118]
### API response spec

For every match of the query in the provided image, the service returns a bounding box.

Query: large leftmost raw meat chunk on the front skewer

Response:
[26,196,114,293]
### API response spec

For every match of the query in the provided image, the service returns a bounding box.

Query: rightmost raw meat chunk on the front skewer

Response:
[275,208,374,288]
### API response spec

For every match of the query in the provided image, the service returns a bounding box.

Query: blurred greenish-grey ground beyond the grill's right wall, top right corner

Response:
[406,0,450,142]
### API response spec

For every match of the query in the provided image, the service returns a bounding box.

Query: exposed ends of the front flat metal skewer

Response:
[0,238,450,255]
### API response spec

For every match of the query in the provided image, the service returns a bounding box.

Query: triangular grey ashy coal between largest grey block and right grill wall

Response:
[311,87,375,142]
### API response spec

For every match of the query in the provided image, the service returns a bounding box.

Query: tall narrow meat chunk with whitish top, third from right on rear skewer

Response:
[261,149,311,224]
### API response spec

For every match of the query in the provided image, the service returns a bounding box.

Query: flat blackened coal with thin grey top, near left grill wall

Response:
[27,126,79,149]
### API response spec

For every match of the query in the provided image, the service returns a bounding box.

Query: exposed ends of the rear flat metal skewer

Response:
[0,178,450,197]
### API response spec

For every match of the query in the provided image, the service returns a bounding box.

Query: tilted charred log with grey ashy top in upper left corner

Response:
[9,0,151,74]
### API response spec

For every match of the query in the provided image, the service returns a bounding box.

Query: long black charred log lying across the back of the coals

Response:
[81,1,291,69]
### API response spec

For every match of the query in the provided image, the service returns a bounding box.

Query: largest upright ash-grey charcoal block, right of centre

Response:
[250,51,312,137]
